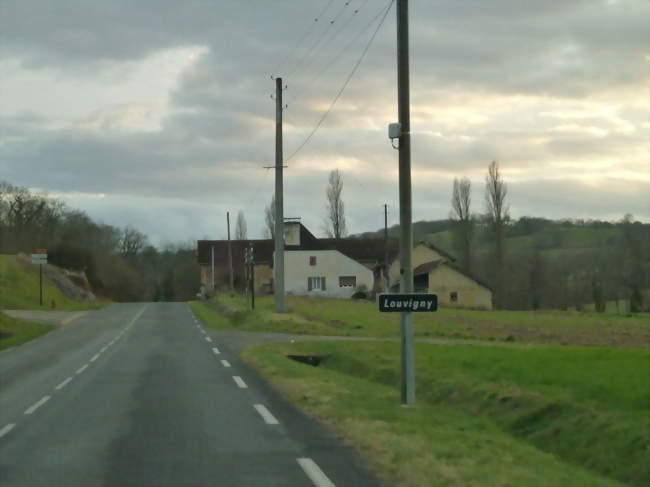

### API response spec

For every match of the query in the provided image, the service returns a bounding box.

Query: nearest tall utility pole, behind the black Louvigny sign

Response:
[397,0,415,405]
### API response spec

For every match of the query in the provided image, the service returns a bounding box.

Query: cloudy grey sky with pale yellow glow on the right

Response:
[0,0,650,243]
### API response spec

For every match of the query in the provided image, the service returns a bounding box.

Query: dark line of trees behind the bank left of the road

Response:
[0,181,199,301]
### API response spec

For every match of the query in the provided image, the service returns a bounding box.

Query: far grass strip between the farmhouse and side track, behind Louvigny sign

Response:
[190,294,650,348]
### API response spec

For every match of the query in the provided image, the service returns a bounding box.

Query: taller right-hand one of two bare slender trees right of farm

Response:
[485,161,510,308]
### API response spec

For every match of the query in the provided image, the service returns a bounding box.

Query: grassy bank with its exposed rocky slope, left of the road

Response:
[0,254,107,311]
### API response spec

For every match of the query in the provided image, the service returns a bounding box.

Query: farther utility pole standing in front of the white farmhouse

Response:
[273,78,284,313]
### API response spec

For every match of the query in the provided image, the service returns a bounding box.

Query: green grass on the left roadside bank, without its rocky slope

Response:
[0,255,109,311]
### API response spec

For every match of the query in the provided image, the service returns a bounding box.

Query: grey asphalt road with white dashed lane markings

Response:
[0,303,379,487]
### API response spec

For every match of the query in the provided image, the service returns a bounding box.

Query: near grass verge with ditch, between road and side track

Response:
[242,341,650,486]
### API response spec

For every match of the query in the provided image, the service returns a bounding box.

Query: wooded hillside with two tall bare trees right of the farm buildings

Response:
[450,162,650,312]
